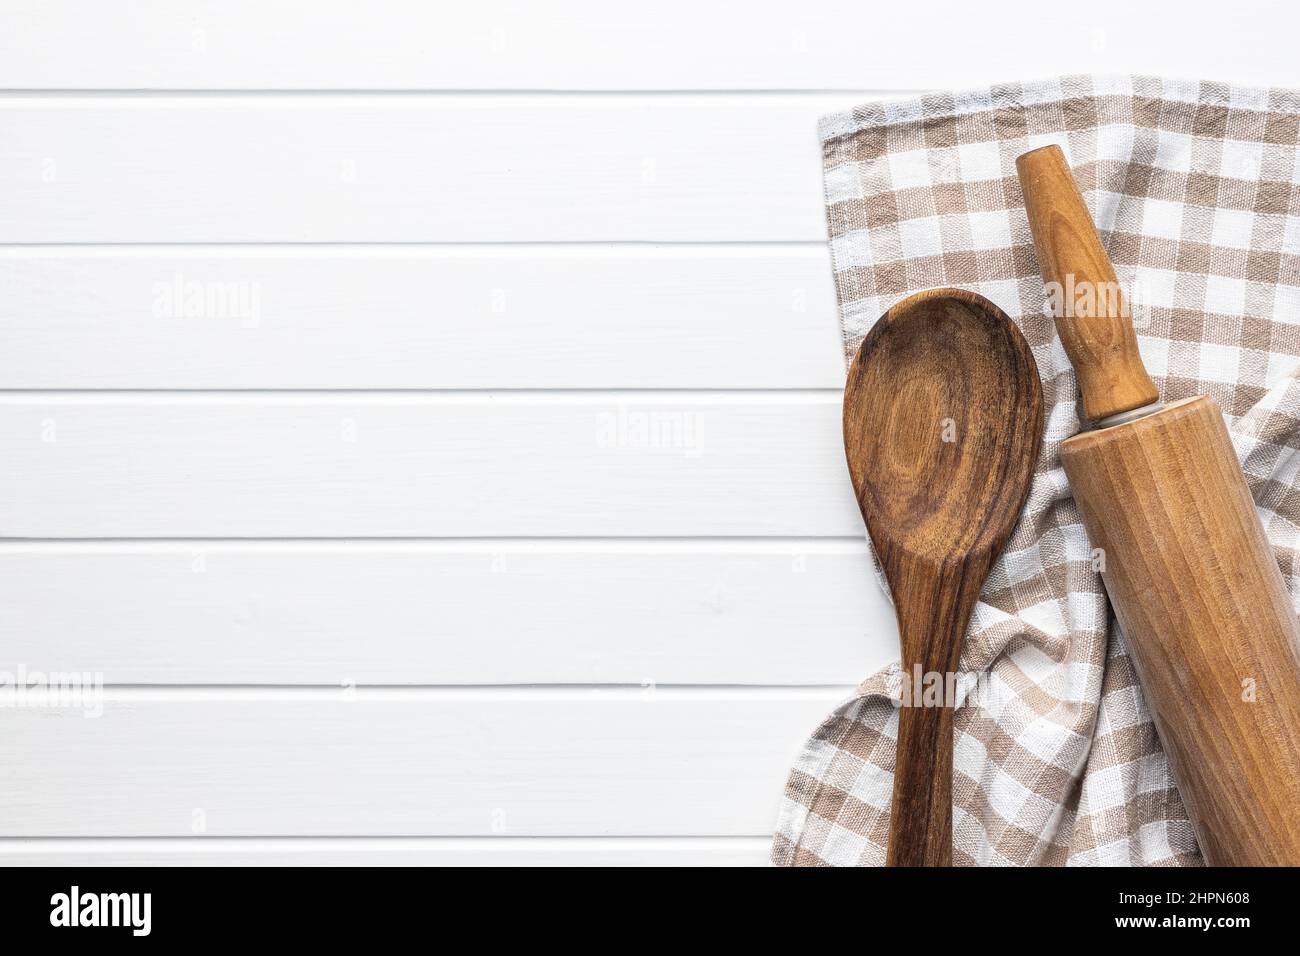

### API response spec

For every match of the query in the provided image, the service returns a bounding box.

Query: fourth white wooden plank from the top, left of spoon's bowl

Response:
[0,392,862,537]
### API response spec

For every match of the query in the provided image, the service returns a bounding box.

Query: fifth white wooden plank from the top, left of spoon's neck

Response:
[0,540,898,685]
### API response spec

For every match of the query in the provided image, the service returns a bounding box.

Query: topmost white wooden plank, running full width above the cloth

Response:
[0,0,1300,90]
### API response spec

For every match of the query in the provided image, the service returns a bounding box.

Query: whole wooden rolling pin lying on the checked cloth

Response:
[1015,146,1300,866]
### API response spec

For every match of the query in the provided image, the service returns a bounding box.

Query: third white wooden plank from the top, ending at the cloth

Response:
[0,243,844,389]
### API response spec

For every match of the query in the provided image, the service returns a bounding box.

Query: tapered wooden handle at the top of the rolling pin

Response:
[1015,146,1160,421]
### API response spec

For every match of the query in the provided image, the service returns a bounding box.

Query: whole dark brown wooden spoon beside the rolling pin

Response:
[844,289,1043,866]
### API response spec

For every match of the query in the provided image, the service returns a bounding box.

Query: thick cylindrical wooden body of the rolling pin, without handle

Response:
[1061,397,1300,866]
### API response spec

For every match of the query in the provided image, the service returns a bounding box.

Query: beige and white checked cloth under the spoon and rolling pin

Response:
[772,77,1300,866]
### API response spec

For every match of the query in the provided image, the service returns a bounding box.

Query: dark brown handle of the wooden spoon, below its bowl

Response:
[885,554,992,866]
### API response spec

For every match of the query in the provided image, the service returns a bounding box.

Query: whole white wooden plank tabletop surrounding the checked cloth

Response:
[0,0,1300,864]
